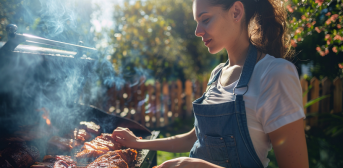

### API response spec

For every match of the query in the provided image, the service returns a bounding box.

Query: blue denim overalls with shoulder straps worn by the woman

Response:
[189,44,263,168]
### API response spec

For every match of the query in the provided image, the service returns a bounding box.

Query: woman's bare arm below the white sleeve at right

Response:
[268,119,309,168]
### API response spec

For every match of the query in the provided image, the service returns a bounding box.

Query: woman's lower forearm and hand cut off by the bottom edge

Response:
[157,157,224,168]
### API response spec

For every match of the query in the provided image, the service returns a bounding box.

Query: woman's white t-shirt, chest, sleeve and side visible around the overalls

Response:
[202,54,305,167]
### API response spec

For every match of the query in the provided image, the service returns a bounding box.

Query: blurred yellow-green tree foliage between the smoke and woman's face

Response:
[109,0,226,80]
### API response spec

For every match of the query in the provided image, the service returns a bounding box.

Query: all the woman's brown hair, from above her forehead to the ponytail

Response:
[210,0,294,59]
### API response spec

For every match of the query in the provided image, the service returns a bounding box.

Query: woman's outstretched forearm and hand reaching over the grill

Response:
[112,127,197,153]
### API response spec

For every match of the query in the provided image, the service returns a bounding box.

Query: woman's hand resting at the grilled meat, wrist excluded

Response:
[112,127,140,148]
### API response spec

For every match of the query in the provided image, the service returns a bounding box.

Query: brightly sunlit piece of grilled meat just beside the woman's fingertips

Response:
[76,133,122,159]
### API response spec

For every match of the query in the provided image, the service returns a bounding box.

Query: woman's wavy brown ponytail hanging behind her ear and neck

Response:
[250,0,292,58]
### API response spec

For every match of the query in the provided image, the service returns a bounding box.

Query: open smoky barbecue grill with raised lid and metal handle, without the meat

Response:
[0,25,159,167]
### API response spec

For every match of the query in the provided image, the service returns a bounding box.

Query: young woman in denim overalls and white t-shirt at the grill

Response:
[113,0,309,168]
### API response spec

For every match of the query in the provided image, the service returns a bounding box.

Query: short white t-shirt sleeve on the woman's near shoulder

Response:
[256,59,305,133]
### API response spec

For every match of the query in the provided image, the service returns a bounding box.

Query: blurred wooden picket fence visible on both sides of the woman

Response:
[102,78,342,128]
